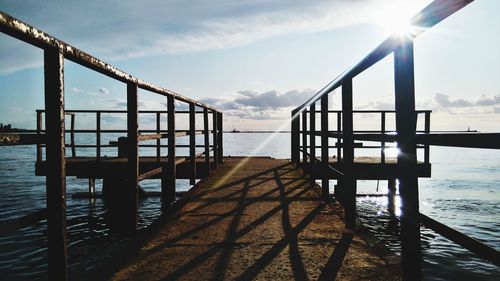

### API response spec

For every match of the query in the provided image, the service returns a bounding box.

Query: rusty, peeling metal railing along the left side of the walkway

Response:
[0,12,222,280]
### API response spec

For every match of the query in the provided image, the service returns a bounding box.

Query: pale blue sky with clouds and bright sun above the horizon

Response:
[0,0,500,132]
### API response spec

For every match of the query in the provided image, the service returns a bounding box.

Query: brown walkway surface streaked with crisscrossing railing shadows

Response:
[108,157,399,280]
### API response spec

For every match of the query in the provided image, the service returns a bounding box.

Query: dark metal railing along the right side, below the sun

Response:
[291,0,500,280]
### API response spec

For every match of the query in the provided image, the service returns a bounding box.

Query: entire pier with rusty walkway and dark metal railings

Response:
[0,0,500,280]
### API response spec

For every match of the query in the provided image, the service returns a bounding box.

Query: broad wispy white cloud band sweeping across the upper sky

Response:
[0,0,428,73]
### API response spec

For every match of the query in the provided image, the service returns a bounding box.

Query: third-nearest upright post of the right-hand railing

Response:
[321,94,330,199]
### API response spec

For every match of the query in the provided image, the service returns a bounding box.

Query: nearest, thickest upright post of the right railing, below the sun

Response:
[394,37,422,280]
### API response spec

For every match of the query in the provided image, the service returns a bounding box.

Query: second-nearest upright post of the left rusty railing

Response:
[125,82,139,231]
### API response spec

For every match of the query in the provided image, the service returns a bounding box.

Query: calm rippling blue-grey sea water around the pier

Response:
[0,133,500,280]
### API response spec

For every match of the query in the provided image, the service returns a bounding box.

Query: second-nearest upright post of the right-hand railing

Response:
[341,77,356,229]
